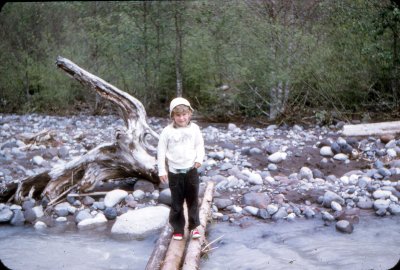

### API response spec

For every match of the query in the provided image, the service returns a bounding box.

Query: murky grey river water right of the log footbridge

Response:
[201,216,400,270]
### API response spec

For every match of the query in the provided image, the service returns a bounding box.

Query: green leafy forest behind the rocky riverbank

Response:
[0,0,400,124]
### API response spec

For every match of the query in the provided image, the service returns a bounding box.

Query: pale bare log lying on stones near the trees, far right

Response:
[342,121,400,136]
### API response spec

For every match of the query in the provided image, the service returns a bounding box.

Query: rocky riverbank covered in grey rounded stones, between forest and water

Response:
[0,114,400,238]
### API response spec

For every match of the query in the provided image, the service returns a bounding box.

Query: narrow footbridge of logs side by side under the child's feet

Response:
[146,181,214,270]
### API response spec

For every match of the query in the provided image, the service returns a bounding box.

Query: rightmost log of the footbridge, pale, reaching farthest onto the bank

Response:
[182,181,214,270]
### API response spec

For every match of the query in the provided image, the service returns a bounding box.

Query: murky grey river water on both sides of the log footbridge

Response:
[0,216,400,270]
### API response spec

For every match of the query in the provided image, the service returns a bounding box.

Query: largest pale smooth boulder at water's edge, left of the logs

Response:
[111,206,170,239]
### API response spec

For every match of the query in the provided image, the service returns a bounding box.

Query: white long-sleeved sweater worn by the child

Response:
[157,123,205,176]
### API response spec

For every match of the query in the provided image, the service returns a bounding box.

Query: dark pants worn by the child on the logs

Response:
[168,168,200,234]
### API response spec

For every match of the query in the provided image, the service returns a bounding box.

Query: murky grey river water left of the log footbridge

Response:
[0,223,157,270]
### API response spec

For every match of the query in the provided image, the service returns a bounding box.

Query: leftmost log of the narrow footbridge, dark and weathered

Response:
[146,224,173,270]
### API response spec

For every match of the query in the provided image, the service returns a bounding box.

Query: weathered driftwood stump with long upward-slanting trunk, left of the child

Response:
[0,57,159,203]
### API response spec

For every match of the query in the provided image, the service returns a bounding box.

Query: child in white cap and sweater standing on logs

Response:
[157,97,205,240]
